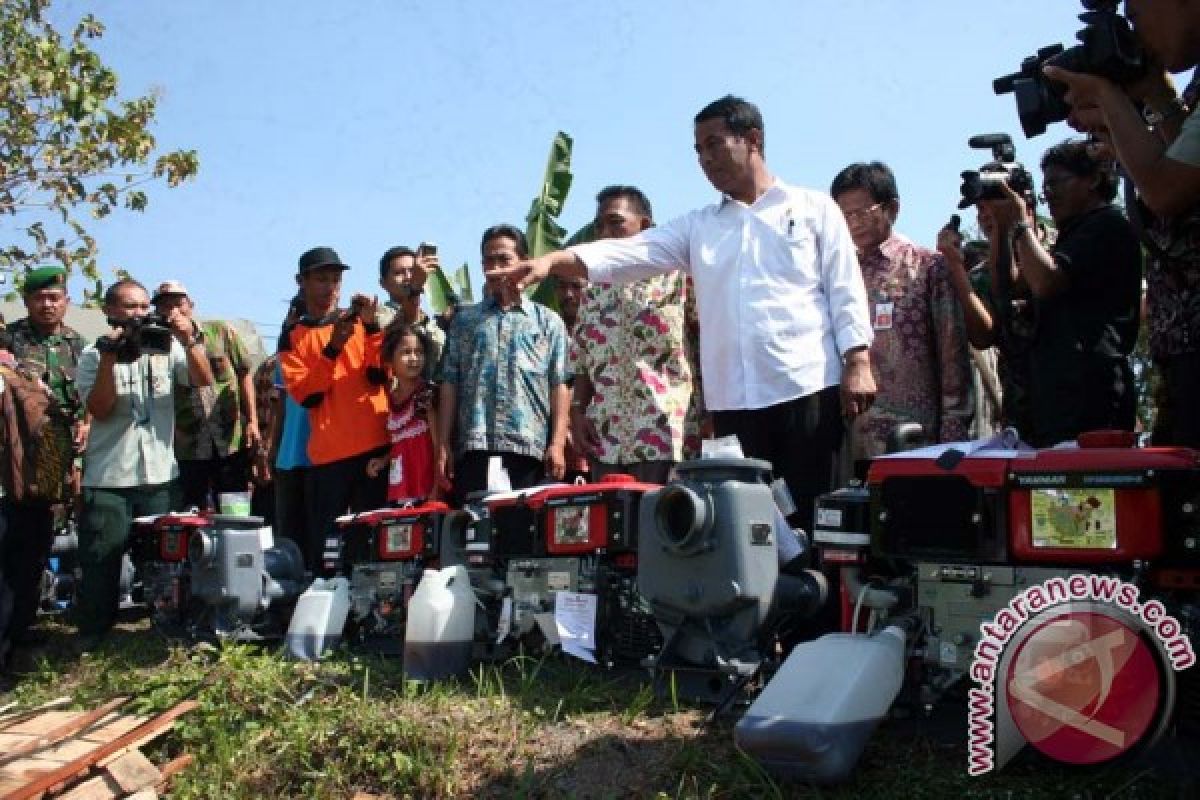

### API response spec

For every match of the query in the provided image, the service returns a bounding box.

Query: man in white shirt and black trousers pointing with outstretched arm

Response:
[506,96,875,528]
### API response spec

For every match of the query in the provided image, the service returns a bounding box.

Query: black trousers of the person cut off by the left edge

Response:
[0,501,54,640]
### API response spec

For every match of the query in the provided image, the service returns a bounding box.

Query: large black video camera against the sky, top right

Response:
[992,0,1147,139]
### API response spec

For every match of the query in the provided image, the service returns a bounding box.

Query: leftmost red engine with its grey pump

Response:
[130,513,305,640]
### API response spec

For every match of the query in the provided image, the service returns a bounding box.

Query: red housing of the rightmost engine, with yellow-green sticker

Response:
[868,438,1200,565]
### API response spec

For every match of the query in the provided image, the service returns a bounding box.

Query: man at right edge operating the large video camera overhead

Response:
[1044,0,1200,447]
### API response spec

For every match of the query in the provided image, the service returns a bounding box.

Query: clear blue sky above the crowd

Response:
[46,0,1099,347]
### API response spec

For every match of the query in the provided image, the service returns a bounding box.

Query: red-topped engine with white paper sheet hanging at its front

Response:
[441,475,661,667]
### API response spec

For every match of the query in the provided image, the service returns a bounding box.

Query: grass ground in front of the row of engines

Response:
[0,621,1200,800]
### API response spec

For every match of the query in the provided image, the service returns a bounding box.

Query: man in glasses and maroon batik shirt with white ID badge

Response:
[829,161,973,461]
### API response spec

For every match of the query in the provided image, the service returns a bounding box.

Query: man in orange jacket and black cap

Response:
[280,247,389,573]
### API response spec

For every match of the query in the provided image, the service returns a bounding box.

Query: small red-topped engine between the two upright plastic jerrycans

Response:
[337,503,450,652]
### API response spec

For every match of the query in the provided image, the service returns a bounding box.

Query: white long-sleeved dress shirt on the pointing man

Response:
[570,180,871,411]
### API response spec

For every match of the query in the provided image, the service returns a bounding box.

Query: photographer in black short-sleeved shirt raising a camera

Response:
[980,140,1141,447]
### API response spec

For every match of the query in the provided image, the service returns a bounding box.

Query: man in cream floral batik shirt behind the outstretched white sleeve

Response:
[571,186,703,483]
